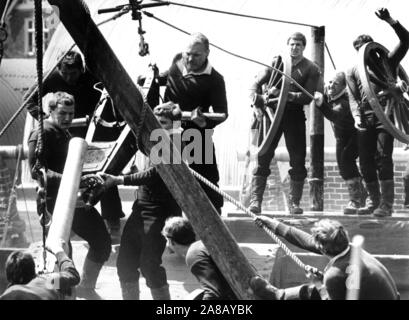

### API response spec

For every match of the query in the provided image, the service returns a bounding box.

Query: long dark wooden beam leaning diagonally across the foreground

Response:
[49,0,256,300]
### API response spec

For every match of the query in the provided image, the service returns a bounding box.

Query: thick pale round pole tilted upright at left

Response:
[46,138,88,253]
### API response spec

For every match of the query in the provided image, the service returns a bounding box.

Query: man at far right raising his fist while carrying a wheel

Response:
[346,8,409,217]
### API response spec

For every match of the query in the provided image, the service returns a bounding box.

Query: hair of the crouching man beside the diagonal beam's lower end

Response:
[162,217,196,246]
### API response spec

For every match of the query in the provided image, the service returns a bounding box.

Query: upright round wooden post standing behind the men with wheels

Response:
[309,26,325,211]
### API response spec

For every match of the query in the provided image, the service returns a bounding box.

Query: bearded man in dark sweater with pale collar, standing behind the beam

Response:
[164,33,228,213]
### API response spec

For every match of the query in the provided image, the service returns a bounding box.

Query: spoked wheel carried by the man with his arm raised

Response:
[358,42,409,144]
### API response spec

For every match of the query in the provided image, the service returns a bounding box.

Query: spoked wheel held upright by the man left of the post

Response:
[255,57,291,156]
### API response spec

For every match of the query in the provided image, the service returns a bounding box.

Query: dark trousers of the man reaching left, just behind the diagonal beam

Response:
[117,200,178,289]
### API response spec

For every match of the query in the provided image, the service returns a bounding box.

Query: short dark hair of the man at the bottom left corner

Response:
[5,251,36,285]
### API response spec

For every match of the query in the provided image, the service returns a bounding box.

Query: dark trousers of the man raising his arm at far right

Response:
[358,126,394,182]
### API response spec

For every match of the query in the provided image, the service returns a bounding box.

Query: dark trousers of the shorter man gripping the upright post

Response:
[335,129,360,180]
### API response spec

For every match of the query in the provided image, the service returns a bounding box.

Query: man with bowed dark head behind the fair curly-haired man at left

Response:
[27,51,125,235]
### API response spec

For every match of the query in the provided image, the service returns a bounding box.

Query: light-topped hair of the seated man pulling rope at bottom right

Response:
[311,219,349,256]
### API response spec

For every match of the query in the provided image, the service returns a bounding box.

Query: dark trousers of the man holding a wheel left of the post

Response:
[253,109,307,181]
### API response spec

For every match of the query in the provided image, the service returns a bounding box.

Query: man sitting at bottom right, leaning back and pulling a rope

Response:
[250,216,399,300]
